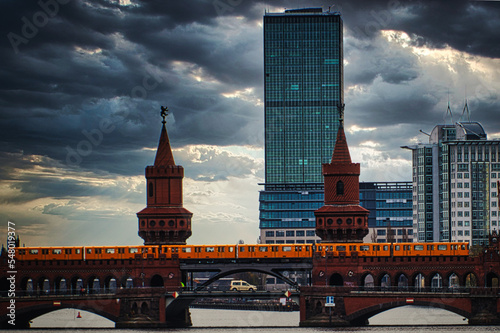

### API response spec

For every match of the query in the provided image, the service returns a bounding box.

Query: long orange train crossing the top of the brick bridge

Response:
[16,243,469,260]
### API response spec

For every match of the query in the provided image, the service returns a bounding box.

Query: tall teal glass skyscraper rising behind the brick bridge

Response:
[259,8,343,243]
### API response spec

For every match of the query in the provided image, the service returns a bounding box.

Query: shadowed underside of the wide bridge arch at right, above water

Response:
[346,299,471,325]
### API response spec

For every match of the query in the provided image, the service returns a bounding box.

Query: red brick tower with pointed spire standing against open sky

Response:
[137,106,193,245]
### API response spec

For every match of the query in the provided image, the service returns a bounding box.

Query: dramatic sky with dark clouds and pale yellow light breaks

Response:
[0,0,500,246]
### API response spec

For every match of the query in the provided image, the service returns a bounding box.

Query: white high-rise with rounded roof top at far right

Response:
[402,122,500,245]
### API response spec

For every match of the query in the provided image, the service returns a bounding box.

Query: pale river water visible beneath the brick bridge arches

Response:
[22,306,500,333]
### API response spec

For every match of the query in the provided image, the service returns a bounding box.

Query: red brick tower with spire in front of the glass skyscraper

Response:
[314,110,369,242]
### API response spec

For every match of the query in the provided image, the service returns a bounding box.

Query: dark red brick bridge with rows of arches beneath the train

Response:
[0,247,500,328]
